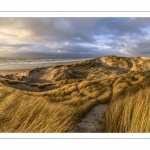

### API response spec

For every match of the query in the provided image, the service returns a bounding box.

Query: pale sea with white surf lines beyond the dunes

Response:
[0,57,89,70]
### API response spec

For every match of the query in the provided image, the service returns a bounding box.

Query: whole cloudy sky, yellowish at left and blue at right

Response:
[0,17,150,57]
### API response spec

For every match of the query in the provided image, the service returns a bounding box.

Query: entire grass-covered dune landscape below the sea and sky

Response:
[0,56,150,132]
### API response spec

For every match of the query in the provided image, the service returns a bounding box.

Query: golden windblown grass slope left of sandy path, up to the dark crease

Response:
[0,77,112,132]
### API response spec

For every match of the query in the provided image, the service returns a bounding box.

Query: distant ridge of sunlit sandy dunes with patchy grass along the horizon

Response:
[5,56,150,83]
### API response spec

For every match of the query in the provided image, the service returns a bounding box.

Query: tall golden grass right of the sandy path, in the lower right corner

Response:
[102,79,150,132]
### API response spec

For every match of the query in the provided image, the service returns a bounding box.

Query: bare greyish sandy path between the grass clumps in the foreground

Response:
[76,104,108,133]
